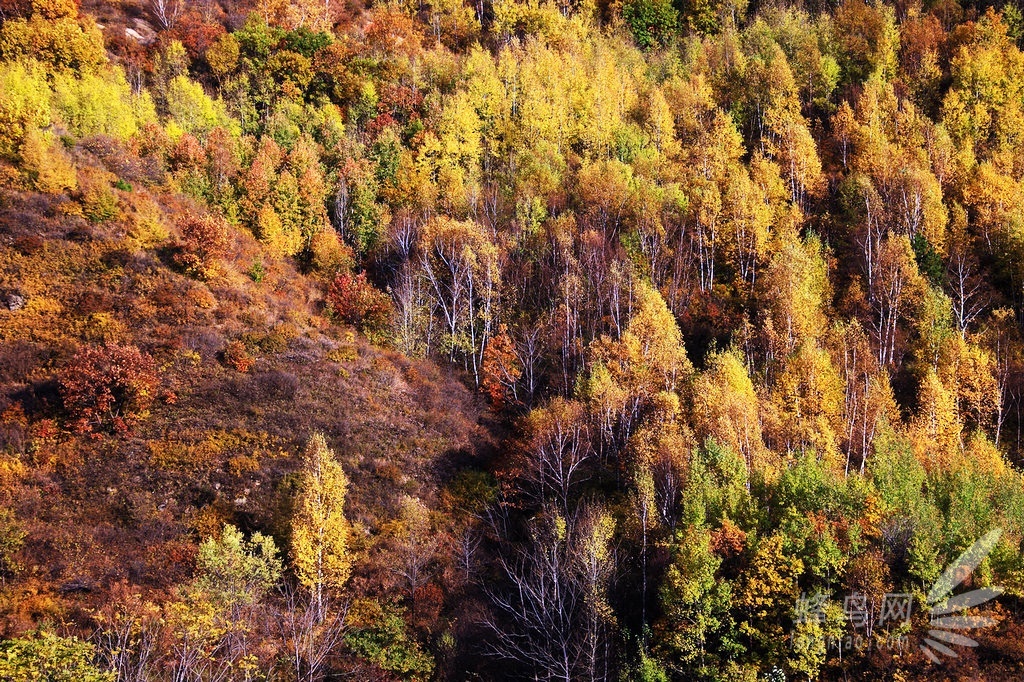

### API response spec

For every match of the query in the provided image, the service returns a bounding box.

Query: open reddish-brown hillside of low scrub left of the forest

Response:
[0,133,493,675]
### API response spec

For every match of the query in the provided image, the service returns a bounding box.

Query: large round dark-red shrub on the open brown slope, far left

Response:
[59,344,159,434]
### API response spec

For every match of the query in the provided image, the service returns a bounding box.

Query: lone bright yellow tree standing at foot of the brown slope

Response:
[292,432,352,621]
